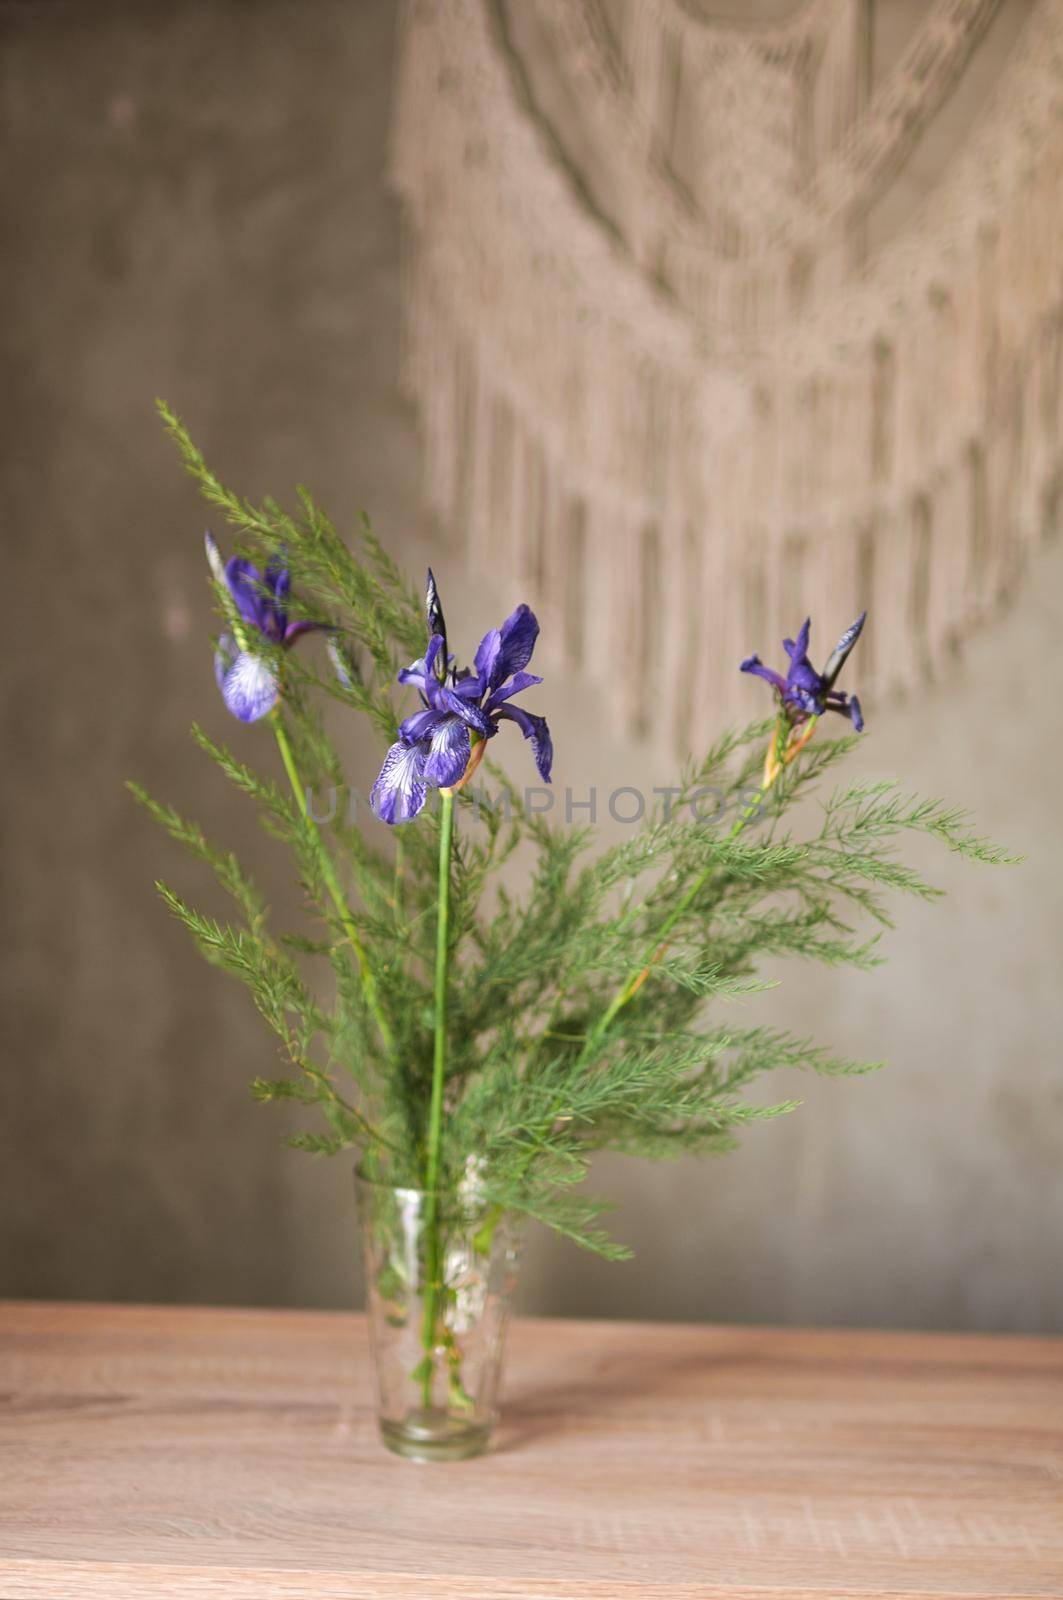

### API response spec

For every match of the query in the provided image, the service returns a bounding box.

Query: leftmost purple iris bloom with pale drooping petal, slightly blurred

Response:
[205,533,327,722]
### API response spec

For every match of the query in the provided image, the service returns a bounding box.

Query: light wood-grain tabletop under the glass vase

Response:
[0,1304,1063,1600]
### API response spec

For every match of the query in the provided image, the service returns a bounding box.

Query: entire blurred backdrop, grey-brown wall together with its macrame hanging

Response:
[0,0,1063,1331]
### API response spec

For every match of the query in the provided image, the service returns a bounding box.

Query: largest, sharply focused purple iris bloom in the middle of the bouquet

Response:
[370,568,554,824]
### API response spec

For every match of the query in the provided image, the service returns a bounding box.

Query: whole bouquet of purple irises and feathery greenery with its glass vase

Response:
[131,405,1009,1458]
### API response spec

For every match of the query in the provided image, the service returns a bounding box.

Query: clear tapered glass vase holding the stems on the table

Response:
[355,1173,519,1461]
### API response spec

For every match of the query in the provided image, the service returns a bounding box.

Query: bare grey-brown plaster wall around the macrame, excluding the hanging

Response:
[0,0,1063,1330]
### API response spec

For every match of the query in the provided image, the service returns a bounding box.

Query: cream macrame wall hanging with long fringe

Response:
[392,0,1063,749]
